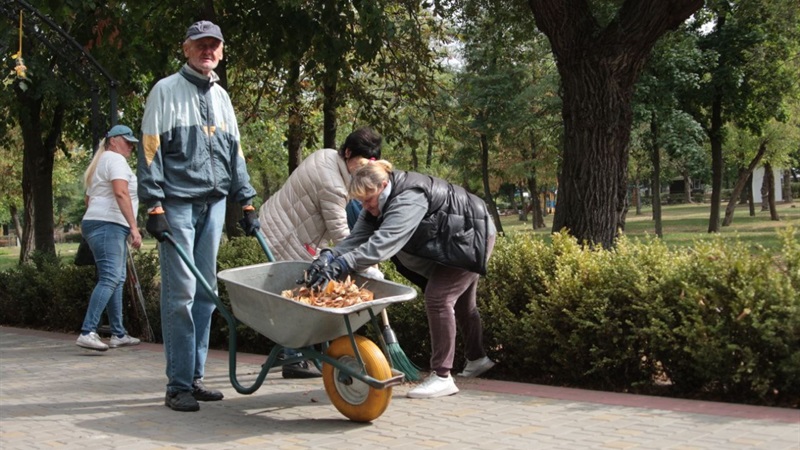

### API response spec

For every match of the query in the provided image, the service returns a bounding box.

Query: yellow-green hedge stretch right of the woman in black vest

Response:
[479,229,800,404]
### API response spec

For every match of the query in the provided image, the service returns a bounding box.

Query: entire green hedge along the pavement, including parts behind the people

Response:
[0,227,800,407]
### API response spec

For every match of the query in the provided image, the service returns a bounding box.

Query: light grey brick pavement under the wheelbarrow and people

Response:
[0,327,800,450]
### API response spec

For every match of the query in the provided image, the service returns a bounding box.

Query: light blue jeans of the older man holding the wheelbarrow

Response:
[158,198,225,393]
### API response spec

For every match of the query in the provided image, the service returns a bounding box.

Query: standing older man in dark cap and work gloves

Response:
[137,20,259,411]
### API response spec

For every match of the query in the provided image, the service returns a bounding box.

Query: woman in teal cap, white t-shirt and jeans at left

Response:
[76,125,142,351]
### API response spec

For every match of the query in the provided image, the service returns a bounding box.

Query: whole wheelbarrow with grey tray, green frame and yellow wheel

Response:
[160,232,416,422]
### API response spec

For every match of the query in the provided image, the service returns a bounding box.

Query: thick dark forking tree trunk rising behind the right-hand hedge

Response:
[528,0,703,248]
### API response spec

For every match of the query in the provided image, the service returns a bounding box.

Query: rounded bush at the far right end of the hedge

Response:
[653,232,800,401]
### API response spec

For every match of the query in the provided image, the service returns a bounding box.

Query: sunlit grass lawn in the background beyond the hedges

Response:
[0,203,800,270]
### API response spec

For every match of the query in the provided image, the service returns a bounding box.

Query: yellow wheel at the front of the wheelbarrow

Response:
[322,335,392,422]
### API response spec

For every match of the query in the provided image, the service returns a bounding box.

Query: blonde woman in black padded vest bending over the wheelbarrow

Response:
[307,160,496,398]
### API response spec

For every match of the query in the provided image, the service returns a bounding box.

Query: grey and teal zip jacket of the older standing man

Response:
[137,65,256,207]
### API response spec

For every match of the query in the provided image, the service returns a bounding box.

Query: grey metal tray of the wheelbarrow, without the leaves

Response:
[217,261,417,348]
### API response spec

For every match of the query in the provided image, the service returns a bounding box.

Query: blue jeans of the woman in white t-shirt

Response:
[81,220,130,336]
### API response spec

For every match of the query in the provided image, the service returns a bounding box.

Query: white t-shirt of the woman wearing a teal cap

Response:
[83,150,139,227]
